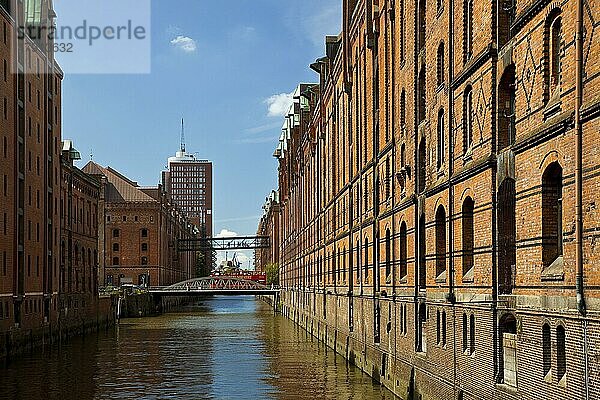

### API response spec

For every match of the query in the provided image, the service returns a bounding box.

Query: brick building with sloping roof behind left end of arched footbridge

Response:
[83,162,195,286]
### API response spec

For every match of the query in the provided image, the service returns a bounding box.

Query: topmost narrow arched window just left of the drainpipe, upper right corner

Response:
[544,8,562,102]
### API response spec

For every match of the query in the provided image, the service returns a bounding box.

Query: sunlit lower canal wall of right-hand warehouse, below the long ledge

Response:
[281,288,600,400]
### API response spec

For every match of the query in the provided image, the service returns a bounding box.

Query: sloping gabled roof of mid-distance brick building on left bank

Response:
[83,161,157,203]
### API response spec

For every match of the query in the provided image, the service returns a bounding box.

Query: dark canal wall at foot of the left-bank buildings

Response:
[0,295,118,360]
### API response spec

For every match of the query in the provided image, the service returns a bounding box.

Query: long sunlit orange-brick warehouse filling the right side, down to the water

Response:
[276,0,600,399]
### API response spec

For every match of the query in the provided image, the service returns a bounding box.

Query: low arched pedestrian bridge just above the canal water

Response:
[148,276,279,296]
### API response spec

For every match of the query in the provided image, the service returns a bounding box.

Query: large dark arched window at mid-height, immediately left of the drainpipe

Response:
[542,162,563,267]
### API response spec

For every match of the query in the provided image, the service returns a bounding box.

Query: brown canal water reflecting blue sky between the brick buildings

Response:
[0,297,394,400]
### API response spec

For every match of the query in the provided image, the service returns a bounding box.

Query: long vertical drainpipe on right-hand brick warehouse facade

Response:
[575,0,590,400]
